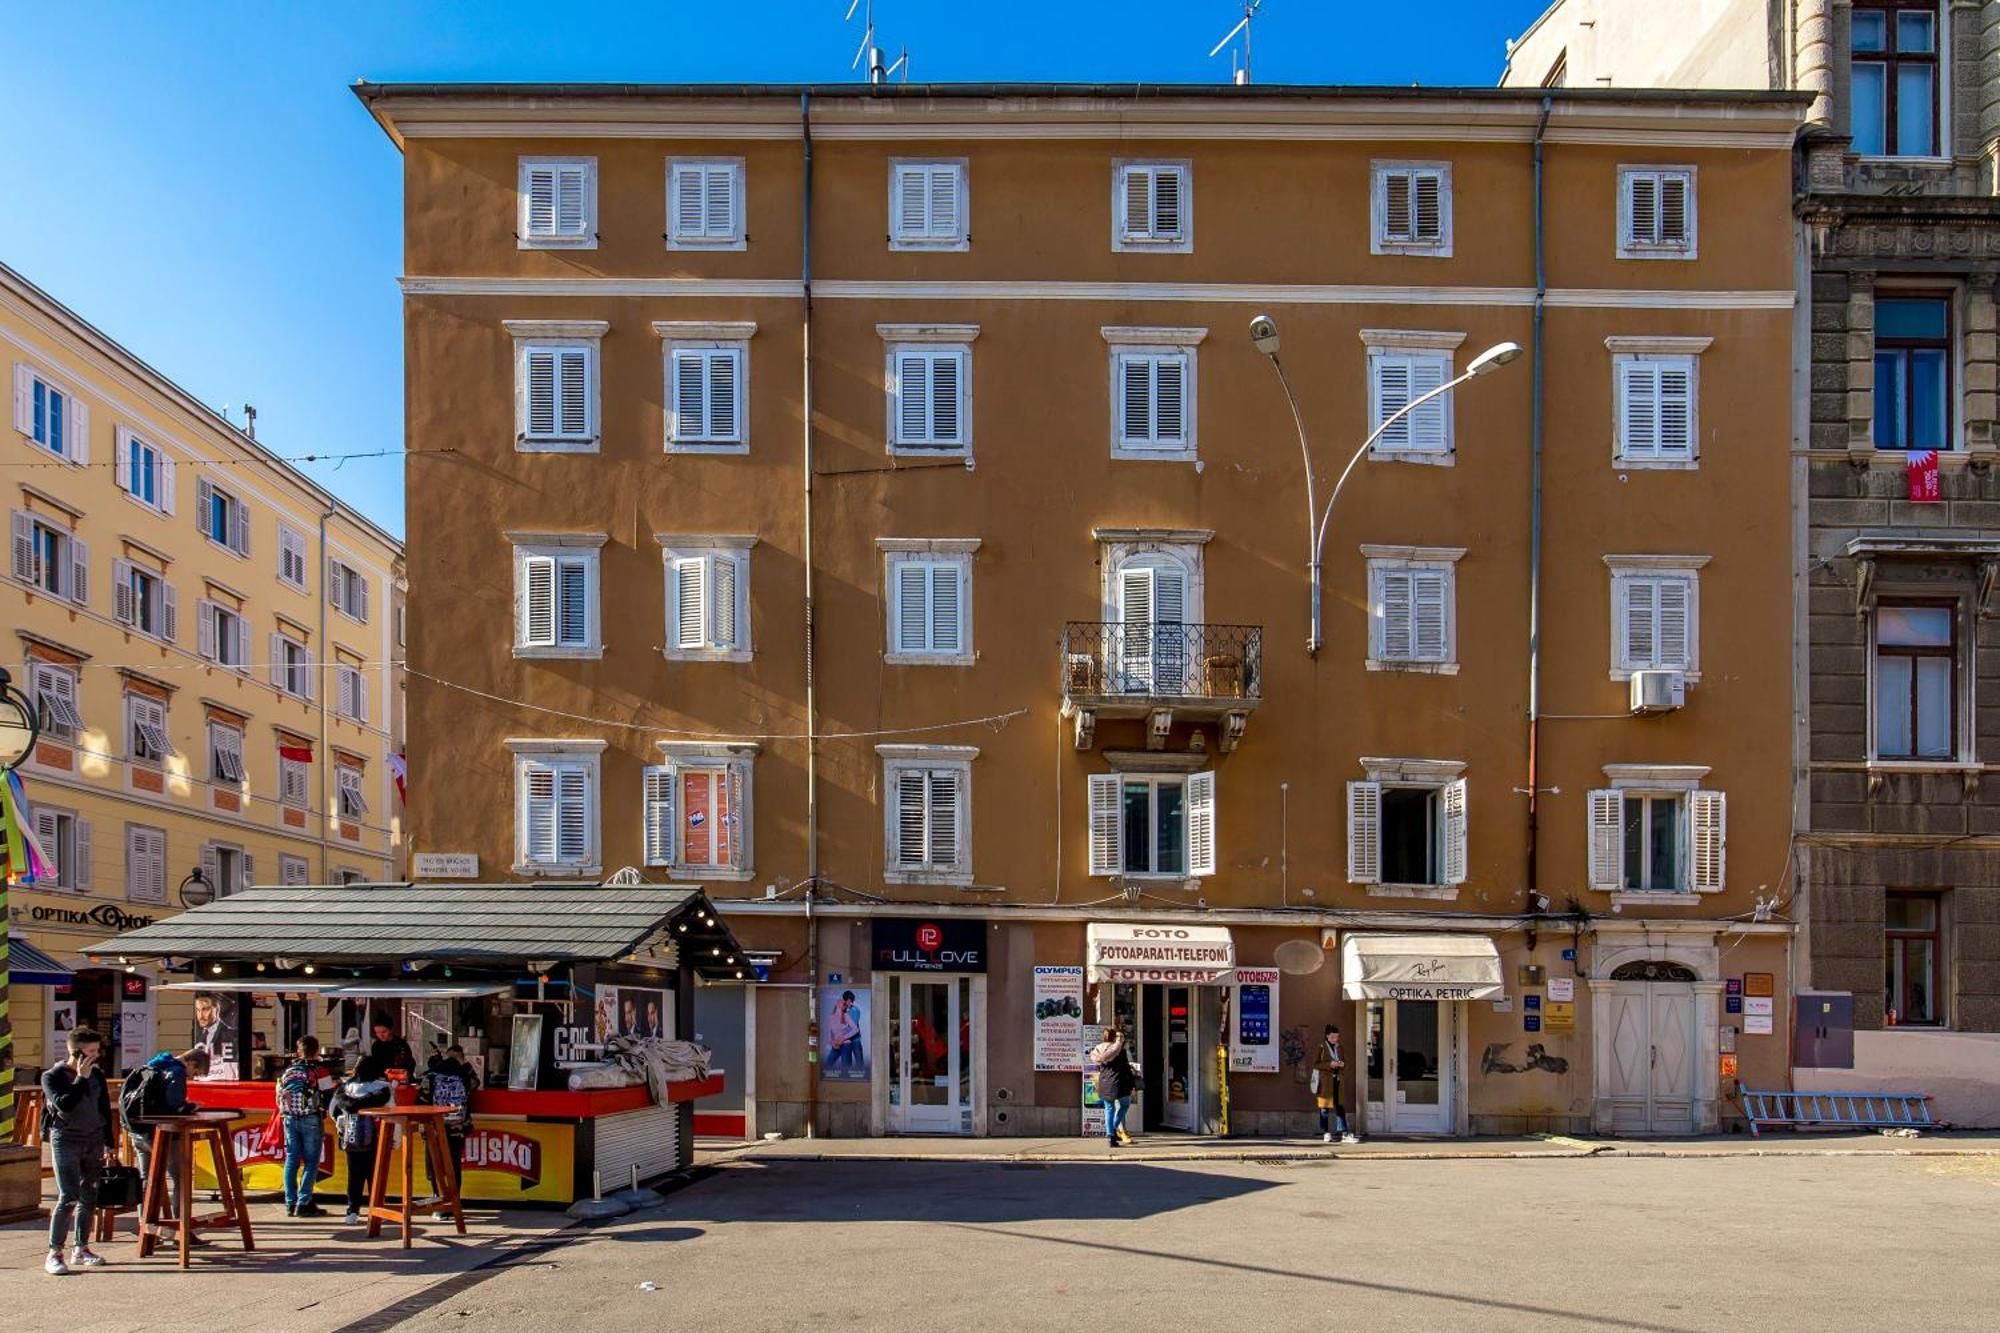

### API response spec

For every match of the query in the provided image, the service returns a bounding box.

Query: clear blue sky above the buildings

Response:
[0,0,1544,534]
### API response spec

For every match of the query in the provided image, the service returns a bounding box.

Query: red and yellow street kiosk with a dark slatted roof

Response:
[86,885,754,1205]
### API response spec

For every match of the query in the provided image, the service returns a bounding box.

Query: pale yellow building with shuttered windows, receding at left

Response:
[0,266,402,1073]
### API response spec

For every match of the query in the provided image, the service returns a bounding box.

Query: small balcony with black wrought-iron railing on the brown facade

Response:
[1062,620,1264,751]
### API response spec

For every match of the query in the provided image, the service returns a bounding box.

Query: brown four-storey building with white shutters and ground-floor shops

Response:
[358,84,1800,1135]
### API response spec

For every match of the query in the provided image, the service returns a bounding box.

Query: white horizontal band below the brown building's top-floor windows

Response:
[400,276,1796,310]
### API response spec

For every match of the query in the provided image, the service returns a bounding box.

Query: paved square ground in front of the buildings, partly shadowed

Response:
[0,1155,2000,1333]
